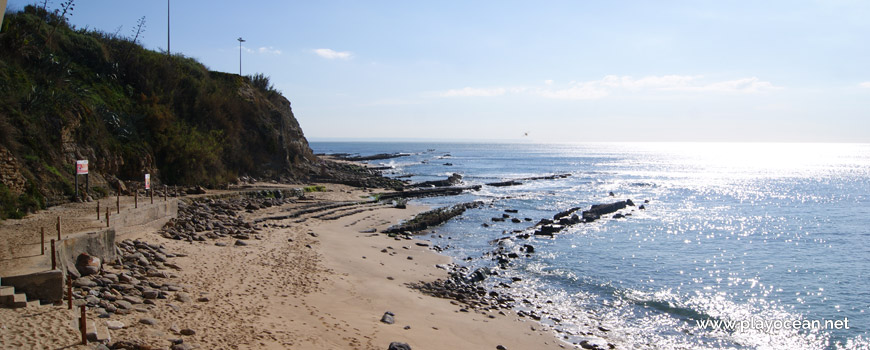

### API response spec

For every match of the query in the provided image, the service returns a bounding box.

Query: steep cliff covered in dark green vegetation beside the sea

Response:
[0,6,323,218]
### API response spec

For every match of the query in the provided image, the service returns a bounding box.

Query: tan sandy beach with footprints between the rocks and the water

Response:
[0,184,567,349]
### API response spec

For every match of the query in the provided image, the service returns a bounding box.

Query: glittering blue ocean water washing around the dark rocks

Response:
[311,142,870,349]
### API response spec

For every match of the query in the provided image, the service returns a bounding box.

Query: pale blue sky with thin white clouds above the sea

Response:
[8,0,870,142]
